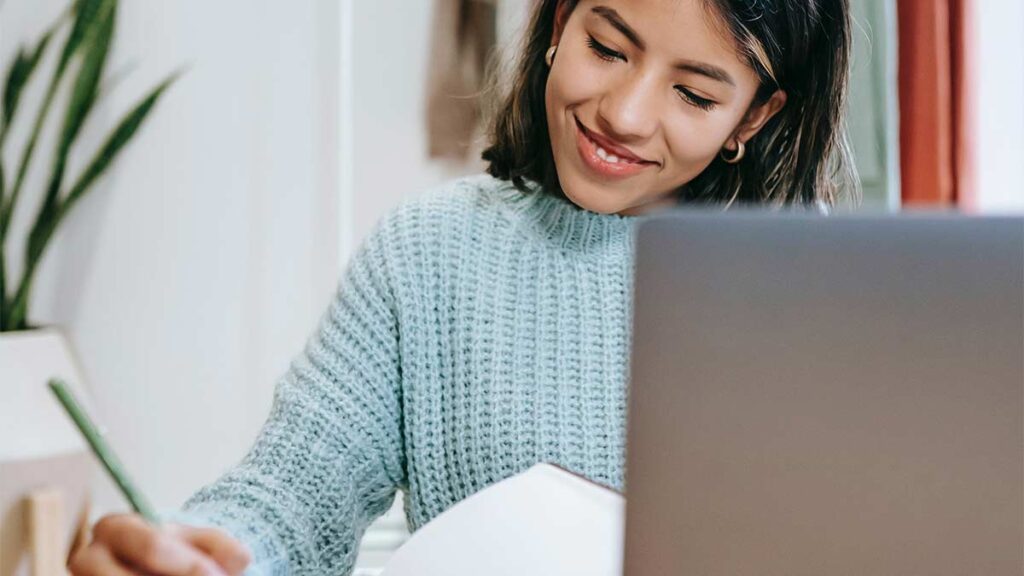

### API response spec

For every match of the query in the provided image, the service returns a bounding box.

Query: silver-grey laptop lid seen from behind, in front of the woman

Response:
[625,213,1024,576]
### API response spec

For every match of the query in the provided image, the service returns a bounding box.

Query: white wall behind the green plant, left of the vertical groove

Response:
[0,0,340,509]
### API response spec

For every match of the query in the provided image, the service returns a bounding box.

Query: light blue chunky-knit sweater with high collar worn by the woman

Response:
[179,176,636,575]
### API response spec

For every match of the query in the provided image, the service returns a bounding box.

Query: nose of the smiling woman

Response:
[597,74,659,143]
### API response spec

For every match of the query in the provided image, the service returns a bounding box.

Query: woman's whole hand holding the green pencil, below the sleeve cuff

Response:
[69,515,251,576]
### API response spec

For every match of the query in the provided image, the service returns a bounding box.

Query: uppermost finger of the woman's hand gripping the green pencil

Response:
[93,515,224,576]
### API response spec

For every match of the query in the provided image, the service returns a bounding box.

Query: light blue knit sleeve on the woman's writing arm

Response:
[170,223,404,575]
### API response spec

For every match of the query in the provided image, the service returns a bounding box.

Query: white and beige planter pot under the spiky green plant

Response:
[0,329,92,576]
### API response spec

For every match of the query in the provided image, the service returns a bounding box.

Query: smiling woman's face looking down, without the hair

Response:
[545,0,785,214]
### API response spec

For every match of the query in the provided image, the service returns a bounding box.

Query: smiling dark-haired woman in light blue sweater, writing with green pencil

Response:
[66,0,850,576]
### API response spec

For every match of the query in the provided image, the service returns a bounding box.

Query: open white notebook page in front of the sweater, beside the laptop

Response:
[382,463,626,576]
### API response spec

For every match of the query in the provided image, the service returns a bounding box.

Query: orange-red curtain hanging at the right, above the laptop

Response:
[897,0,975,207]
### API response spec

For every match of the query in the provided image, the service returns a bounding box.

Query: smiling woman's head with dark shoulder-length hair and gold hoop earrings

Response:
[484,0,856,214]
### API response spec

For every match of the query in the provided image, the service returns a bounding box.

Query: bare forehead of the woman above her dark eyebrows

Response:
[577,0,745,70]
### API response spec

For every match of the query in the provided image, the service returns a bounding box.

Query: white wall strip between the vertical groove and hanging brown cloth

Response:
[342,0,483,258]
